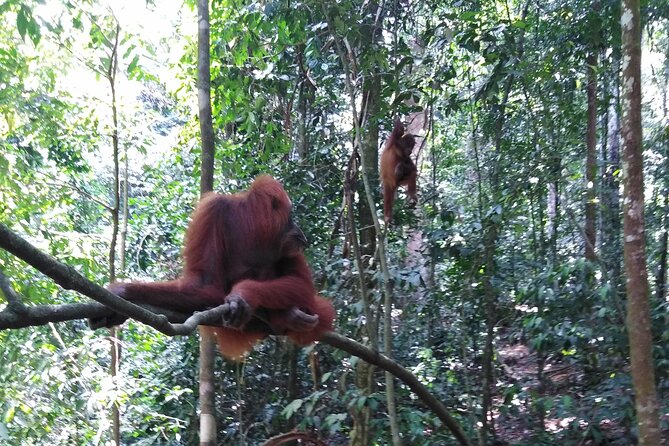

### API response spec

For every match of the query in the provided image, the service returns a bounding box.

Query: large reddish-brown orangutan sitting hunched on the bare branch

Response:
[90,176,335,359]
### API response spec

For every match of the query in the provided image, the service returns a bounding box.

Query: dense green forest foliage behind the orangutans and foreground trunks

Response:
[0,0,669,446]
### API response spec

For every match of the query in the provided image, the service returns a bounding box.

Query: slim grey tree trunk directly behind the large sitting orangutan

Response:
[197,0,216,446]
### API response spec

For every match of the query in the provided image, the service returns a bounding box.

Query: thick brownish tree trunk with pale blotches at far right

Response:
[620,0,661,446]
